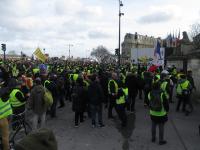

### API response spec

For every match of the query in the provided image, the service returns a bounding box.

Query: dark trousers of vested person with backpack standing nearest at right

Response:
[151,121,164,141]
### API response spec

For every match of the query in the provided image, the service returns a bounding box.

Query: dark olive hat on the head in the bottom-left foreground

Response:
[15,129,58,150]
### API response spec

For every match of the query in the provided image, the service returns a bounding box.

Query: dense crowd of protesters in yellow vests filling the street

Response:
[0,61,196,150]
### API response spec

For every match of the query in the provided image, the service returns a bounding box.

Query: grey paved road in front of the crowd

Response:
[47,97,200,150]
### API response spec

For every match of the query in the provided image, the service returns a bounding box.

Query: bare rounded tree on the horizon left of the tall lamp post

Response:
[90,45,115,63]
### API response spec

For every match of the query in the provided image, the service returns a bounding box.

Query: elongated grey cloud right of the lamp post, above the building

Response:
[138,12,173,24]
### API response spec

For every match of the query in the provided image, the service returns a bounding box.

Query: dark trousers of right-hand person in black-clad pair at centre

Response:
[90,104,103,125]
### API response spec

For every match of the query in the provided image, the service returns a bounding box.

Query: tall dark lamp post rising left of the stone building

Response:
[118,0,124,67]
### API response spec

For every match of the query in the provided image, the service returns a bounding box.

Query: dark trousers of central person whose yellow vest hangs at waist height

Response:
[115,104,127,127]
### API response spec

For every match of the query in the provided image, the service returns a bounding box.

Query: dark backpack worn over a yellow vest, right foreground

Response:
[149,92,162,111]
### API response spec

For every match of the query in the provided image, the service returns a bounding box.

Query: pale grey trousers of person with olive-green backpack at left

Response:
[33,112,46,130]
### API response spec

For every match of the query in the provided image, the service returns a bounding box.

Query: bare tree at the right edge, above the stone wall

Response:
[190,23,200,49]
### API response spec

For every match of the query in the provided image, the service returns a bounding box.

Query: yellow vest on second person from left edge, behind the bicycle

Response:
[9,89,26,107]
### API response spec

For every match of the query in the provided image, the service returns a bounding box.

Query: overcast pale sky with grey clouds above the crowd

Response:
[0,0,200,57]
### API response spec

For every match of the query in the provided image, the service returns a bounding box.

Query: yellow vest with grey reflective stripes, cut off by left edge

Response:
[0,98,13,119]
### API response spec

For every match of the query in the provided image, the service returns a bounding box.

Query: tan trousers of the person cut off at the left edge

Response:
[0,118,10,150]
